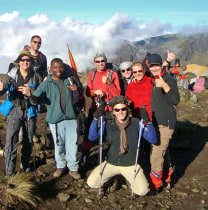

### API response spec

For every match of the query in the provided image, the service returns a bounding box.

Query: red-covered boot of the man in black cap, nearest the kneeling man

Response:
[150,170,163,190]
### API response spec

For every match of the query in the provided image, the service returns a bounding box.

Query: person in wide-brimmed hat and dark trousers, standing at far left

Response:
[0,50,41,177]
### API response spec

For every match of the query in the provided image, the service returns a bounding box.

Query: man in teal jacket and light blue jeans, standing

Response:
[23,58,80,179]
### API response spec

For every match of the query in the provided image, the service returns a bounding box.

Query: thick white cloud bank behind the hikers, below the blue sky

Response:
[0,11,208,73]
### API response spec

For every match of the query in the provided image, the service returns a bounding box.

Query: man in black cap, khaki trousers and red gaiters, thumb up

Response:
[148,54,180,189]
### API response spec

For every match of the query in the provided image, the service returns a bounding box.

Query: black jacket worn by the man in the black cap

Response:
[151,72,180,129]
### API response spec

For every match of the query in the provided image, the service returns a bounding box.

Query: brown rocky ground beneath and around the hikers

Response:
[0,87,208,210]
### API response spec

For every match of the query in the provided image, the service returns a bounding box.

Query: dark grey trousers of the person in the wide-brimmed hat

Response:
[5,107,36,172]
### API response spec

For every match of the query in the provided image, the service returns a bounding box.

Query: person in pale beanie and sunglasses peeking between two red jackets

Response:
[119,61,133,95]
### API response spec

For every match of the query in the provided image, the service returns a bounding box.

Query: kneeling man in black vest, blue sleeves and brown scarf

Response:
[87,96,157,196]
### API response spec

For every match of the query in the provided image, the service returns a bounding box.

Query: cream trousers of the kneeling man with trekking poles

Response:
[87,161,149,196]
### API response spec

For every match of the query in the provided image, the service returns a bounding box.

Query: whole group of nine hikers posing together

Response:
[0,35,180,196]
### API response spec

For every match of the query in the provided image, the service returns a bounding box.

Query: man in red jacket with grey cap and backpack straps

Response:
[81,53,121,161]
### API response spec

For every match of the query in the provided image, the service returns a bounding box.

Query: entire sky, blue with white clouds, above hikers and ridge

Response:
[0,0,208,73]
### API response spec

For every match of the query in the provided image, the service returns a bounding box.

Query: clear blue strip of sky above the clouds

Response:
[0,0,208,25]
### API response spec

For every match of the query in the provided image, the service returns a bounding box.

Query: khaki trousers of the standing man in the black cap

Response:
[150,125,174,172]
